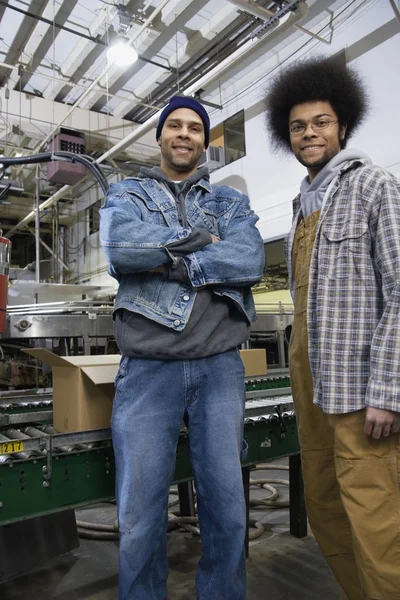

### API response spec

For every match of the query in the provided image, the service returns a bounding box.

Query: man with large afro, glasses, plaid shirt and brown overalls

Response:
[266,57,400,600]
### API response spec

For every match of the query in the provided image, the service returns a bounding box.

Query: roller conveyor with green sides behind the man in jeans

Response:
[0,380,299,526]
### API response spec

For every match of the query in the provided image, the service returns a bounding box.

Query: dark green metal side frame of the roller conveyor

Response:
[0,414,299,526]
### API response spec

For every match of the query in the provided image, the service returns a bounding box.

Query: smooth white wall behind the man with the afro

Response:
[211,2,400,240]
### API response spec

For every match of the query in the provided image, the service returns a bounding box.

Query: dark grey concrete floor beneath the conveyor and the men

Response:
[0,464,339,600]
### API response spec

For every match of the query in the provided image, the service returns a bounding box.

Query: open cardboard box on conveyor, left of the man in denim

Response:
[25,348,121,433]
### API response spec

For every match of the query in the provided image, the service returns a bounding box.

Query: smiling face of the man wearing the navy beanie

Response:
[158,108,204,181]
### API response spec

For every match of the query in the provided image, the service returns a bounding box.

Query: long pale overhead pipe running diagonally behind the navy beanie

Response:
[7,0,308,238]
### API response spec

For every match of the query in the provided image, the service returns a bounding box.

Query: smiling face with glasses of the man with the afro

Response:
[289,100,346,181]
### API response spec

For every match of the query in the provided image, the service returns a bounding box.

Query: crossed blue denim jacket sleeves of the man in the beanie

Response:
[100,193,264,288]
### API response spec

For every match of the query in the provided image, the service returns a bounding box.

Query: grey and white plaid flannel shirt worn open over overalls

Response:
[286,160,400,413]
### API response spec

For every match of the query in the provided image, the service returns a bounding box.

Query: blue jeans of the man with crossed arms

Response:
[112,350,246,600]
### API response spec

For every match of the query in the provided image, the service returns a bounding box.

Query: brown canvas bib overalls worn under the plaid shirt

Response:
[289,213,400,600]
